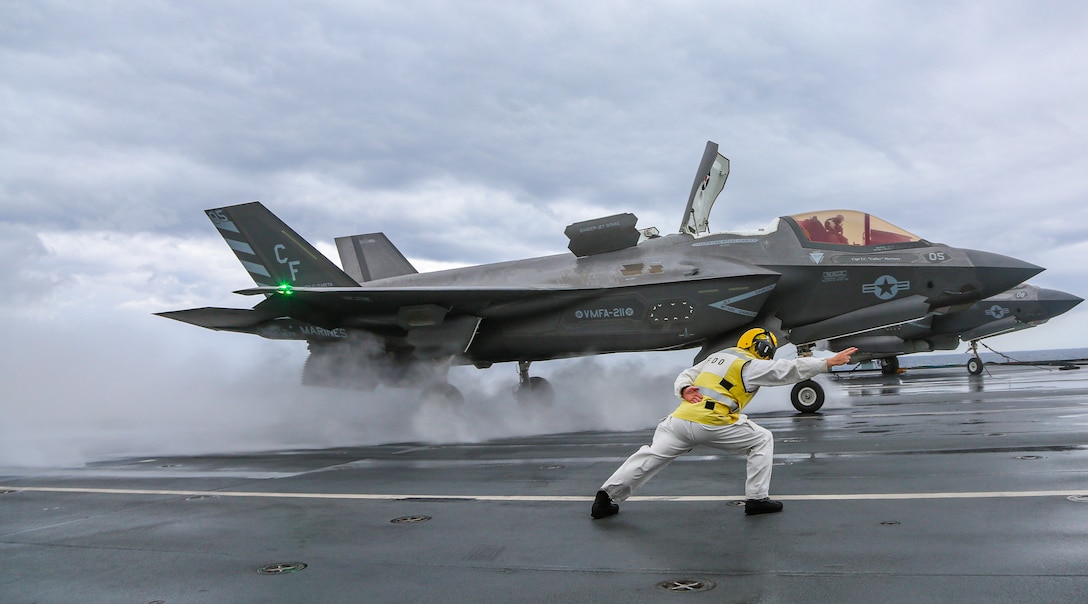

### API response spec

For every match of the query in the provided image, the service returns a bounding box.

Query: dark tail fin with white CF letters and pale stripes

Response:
[205,201,359,287]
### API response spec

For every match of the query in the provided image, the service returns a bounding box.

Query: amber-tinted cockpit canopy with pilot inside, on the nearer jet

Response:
[784,210,925,247]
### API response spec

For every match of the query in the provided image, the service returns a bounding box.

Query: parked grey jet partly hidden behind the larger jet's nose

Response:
[829,283,1084,375]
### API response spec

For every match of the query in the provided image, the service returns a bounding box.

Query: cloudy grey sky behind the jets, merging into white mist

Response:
[0,0,1088,465]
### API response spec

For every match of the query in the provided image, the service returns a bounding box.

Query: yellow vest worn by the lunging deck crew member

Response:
[672,348,759,426]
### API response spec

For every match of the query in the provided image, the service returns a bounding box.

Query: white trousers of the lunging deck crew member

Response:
[601,416,775,502]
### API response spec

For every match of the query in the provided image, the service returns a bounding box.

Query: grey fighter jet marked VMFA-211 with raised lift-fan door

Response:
[159,141,1042,408]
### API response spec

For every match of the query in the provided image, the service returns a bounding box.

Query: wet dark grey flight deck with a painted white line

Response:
[0,367,1088,603]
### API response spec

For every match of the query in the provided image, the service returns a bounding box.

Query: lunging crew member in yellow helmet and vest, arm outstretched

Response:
[590,328,857,518]
